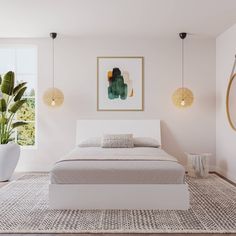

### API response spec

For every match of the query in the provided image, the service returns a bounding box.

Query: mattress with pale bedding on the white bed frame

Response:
[50,147,185,184]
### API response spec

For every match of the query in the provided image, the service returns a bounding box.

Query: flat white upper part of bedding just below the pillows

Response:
[59,147,177,162]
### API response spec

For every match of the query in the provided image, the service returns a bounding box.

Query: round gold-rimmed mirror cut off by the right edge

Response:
[226,73,236,131]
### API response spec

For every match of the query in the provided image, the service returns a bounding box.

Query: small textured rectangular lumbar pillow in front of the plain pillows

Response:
[101,134,134,148]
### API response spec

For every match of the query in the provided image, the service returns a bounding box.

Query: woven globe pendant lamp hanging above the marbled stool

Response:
[172,32,194,108]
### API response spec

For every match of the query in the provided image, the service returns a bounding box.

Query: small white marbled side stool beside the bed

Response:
[186,153,211,178]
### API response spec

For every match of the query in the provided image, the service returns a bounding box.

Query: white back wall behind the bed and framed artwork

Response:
[0,37,215,170]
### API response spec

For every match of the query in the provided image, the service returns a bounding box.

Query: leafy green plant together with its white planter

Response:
[0,71,27,181]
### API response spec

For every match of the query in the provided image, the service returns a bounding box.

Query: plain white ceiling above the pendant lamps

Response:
[0,0,236,38]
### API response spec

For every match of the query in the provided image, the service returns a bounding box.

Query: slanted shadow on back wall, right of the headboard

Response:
[161,121,187,165]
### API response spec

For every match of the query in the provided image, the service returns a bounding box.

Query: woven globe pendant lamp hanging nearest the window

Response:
[43,33,64,107]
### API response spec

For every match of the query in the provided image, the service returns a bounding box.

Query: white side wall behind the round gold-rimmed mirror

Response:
[216,25,236,181]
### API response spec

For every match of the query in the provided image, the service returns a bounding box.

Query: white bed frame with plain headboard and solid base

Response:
[49,120,189,210]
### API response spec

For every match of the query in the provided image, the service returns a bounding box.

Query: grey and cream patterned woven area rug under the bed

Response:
[0,174,236,233]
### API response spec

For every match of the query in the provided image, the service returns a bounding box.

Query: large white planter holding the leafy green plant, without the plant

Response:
[0,142,20,181]
